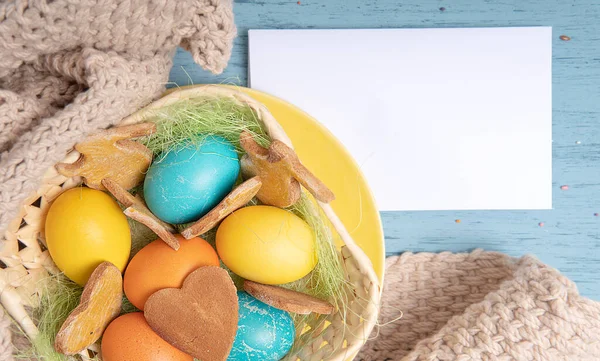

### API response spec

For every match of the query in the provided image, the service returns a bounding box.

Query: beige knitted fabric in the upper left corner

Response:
[0,0,236,234]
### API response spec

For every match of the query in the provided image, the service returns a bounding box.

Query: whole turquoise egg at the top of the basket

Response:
[144,135,240,224]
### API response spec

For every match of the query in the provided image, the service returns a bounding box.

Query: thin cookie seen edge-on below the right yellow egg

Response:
[244,280,333,315]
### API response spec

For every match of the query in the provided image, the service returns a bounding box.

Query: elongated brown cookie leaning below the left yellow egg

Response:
[54,262,123,355]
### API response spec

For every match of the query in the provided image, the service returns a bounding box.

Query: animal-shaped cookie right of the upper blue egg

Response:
[240,131,335,208]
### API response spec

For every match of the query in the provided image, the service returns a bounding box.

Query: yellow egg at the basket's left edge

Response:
[45,187,131,285]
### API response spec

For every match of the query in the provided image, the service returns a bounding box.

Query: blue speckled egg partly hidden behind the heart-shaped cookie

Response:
[227,292,295,361]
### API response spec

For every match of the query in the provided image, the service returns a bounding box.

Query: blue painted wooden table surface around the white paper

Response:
[171,0,600,300]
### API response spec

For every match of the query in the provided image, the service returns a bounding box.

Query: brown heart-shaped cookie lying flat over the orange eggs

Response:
[144,266,238,361]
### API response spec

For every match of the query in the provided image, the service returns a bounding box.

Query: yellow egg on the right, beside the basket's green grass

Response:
[216,206,317,284]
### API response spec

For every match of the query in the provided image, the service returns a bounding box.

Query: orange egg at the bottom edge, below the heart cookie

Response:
[101,312,193,361]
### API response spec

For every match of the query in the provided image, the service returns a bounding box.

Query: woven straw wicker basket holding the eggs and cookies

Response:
[0,85,380,361]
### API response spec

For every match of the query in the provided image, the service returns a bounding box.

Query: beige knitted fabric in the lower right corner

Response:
[357,250,600,361]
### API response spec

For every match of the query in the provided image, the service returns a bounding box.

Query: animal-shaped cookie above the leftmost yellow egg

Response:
[56,123,156,190]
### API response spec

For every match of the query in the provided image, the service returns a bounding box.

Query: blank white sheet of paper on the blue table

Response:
[249,27,552,211]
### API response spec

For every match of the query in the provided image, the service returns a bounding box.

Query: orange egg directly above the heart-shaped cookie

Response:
[123,235,219,310]
